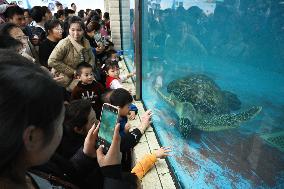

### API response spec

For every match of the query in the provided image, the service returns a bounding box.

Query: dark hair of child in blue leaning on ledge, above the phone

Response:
[109,88,133,108]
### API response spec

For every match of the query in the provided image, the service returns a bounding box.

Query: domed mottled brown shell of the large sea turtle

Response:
[167,74,229,115]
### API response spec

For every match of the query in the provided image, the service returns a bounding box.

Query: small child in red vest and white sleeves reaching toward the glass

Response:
[104,60,135,89]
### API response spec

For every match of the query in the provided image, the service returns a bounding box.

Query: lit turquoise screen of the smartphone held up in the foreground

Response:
[99,105,118,144]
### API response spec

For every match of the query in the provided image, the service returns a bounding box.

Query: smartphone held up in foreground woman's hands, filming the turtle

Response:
[97,103,119,153]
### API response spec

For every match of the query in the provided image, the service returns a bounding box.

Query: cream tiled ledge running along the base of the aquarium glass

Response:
[120,62,176,189]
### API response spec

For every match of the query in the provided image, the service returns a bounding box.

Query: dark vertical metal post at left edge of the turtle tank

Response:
[134,0,142,100]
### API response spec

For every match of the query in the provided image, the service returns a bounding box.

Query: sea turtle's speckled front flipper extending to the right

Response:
[197,106,262,131]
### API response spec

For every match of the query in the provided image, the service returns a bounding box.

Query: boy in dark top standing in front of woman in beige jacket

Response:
[71,62,105,119]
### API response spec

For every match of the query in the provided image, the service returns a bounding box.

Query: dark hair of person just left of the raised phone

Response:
[63,99,92,132]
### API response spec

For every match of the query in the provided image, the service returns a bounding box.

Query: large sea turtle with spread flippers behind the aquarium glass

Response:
[155,74,262,138]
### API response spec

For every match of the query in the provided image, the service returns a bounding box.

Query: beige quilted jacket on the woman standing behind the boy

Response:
[48,36,95,90]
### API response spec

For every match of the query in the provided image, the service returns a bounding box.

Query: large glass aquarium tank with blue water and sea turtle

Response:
[141,0,284,189]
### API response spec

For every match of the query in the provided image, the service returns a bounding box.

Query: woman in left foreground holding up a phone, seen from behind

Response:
[0,50,135,189]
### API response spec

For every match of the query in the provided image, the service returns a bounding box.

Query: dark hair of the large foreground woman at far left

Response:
[0,50,63,182]
